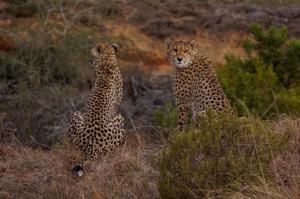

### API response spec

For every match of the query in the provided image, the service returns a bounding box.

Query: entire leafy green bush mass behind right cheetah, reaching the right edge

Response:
[218,25,300,116]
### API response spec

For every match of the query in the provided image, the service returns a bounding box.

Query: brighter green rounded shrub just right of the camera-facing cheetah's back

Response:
[219,55,277,114]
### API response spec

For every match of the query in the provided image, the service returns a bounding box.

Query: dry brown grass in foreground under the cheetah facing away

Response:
[0,133,159,198]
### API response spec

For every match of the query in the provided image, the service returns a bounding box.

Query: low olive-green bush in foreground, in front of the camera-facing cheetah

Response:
[157,113,289,198]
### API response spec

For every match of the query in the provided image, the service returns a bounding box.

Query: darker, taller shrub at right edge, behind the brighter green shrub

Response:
[247,24,300,88]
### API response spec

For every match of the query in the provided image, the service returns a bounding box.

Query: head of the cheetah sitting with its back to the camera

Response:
[90,43,118,66]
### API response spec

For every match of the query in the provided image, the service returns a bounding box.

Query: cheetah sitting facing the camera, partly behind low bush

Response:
[165,39,229,130]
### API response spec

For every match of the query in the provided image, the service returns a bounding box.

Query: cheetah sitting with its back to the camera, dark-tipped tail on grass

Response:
[68,43,124,177]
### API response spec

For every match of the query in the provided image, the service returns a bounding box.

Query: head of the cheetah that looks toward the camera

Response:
[165,39,197,68]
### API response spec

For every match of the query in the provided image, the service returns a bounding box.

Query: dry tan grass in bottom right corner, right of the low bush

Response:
[225,118,300,199]
